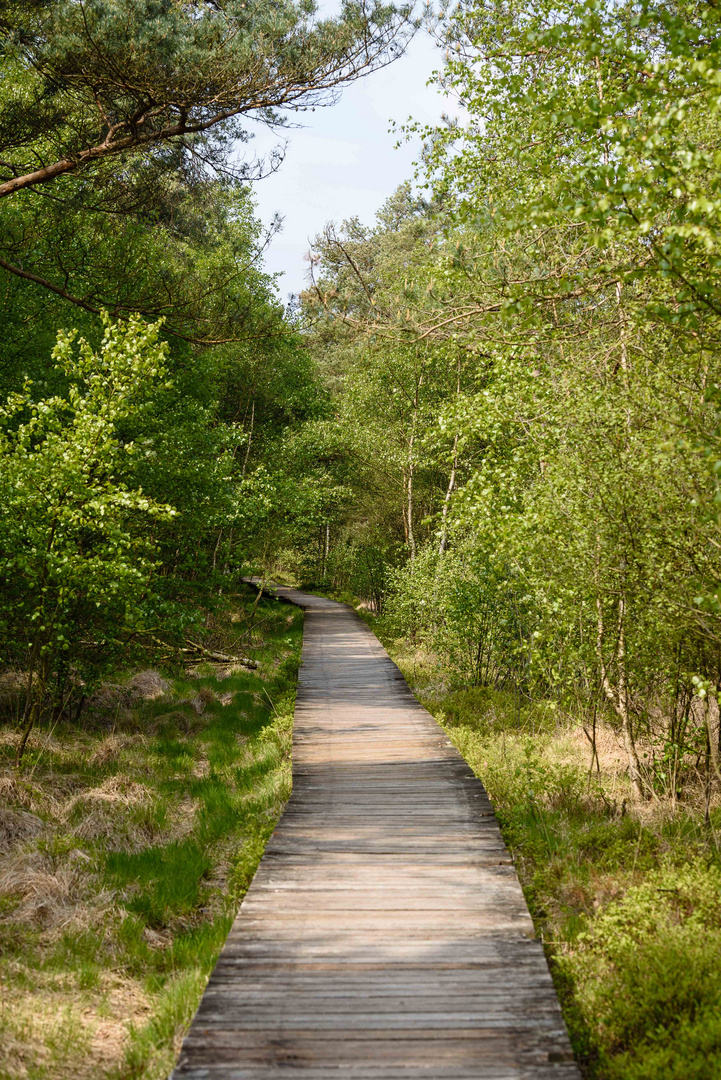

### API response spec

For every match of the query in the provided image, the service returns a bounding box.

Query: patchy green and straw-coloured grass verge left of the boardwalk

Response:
[0,591,302,1080]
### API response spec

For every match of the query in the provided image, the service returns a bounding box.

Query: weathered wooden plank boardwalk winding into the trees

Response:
[174,590,579,1080]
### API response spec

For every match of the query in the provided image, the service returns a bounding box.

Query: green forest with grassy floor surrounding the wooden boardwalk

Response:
[0,0,721,1080]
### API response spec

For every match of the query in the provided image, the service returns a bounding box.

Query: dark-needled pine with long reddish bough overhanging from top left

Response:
[0,0,410,314]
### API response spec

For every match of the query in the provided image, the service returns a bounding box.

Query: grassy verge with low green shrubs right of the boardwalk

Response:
[359,611,721,1080]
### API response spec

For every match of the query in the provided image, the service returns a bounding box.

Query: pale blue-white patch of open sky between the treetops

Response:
[246,31,447,301]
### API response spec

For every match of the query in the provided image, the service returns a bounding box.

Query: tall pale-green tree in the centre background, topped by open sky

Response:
[303,184,479,558]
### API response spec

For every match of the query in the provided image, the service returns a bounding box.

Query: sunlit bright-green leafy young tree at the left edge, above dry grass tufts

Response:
[0,318,175,762]
